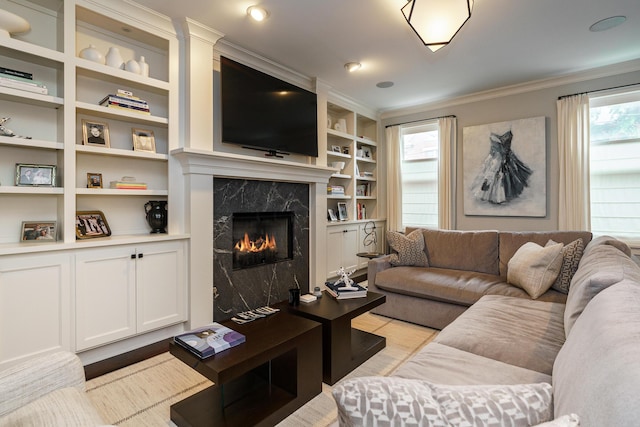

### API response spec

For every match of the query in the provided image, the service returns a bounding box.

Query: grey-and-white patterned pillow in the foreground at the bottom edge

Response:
[333,377,552,427]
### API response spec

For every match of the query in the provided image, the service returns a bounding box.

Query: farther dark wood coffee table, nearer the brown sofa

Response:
[277,291,387,385]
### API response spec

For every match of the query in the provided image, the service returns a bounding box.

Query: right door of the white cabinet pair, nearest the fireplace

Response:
[136,242,186,333]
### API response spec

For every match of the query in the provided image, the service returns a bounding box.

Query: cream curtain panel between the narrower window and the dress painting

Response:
[438,117,458,230]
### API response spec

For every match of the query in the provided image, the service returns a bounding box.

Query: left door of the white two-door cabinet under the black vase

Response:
[76,247,136,350]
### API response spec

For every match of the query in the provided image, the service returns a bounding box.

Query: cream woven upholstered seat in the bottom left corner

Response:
[0,351,110,427]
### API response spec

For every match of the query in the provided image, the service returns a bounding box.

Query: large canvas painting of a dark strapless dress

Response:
[462,117,547,217]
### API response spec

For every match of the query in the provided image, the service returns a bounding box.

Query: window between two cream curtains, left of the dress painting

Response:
[401,121,439,228]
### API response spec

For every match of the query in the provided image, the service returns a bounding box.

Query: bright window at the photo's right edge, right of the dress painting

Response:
[589,91,640,243]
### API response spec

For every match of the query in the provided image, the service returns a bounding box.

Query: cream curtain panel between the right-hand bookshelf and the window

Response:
[386,126,404,231]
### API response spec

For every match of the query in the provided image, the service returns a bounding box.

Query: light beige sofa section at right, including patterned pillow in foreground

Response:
[333,237,640,427]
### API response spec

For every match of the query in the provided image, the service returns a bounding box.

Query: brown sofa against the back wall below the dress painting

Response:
[367,229,592,329]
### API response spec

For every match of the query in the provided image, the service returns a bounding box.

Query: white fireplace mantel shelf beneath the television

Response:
[171,148,336,183]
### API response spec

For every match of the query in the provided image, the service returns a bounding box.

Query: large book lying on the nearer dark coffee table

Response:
[173,322,246,359]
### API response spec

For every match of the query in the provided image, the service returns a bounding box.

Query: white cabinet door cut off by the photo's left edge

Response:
[0,254,71,370]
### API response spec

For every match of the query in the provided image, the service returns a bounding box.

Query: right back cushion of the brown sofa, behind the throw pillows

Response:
[499,231,592,277]
